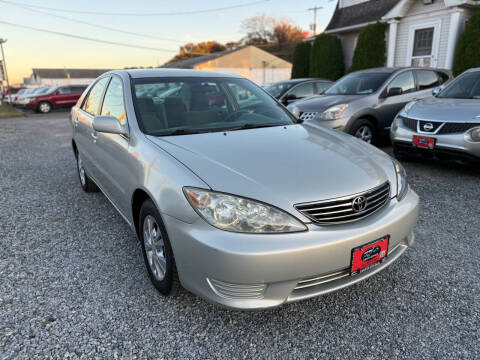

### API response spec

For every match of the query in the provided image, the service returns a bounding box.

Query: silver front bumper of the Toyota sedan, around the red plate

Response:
[163,190,419,309]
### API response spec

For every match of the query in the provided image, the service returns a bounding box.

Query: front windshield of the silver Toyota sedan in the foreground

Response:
[132,77,296,136]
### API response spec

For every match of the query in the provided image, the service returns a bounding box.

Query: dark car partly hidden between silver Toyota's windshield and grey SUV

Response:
[265,78,333,105]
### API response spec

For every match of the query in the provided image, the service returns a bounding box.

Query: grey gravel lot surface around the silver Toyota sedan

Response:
[0,112,480,359]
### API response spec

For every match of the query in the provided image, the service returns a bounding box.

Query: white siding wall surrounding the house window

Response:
[395,0,450,68]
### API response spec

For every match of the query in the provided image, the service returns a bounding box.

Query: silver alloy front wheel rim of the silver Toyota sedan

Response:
[143,215,167,281]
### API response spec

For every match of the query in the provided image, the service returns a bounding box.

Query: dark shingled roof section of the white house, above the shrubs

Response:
[325,0,398,32]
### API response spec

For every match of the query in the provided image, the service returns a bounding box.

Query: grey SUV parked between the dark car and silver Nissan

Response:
[289,68,451,143]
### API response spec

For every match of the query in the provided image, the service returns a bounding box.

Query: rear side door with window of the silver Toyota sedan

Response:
[73,77,110,181]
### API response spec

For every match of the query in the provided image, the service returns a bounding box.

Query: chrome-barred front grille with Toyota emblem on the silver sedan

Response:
[295,181,390,225]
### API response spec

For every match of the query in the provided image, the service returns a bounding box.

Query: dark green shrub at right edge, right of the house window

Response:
[453,10,480,76]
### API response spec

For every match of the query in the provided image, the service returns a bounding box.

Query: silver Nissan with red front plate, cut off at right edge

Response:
[391,68,480,163]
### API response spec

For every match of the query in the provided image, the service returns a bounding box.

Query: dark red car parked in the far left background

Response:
[26,85,87,113]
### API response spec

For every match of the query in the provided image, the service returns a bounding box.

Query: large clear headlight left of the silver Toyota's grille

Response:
[183,187,307,233]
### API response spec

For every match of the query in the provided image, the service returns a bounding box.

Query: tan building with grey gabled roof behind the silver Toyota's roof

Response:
[162,46,292,85]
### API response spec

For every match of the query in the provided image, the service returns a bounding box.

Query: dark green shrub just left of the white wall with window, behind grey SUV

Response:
[348,22,387,72]
